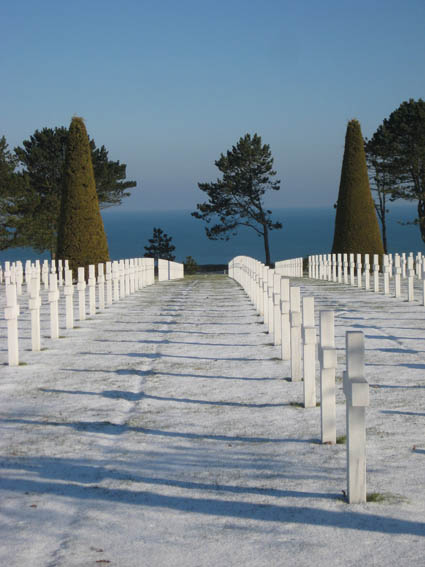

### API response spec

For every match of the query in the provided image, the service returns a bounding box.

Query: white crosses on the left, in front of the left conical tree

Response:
[5,258,155,366]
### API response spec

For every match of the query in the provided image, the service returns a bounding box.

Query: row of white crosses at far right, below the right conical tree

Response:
[308,252,425,305]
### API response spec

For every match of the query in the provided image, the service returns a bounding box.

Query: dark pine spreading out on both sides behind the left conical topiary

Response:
[0,127,136,255]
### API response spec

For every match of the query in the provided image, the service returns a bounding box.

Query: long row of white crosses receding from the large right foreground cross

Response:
[229,256,369,503]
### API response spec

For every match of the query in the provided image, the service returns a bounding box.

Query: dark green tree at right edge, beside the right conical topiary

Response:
[366,99,425,242]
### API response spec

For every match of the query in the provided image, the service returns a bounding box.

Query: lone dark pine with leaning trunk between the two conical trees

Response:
[192,134,282,265]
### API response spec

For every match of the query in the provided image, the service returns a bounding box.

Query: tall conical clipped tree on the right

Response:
[332,120,384,254]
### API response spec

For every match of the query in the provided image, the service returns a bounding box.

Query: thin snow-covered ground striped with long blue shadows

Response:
[0,276,425,567]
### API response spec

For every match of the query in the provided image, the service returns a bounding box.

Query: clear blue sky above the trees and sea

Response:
[0,0,425,210]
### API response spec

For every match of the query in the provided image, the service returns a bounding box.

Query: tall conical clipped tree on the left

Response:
[57,117,109,273]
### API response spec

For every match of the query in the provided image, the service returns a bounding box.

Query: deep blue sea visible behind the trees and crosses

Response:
[0,205,425,265]
